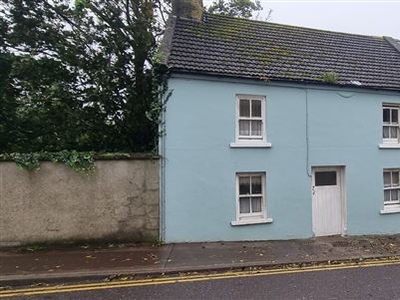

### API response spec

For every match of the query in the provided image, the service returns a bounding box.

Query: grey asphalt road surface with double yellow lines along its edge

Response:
[0,263,400,300]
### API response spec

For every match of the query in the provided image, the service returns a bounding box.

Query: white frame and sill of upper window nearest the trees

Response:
[230,94,271,148]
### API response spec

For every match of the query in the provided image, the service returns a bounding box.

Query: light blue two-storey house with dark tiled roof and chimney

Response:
[161,1,400,242]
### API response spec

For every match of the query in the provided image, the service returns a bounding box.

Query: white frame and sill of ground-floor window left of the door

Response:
[231,172,272,226]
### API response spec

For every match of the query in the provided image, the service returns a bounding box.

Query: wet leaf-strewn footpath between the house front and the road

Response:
[0,234,400,288]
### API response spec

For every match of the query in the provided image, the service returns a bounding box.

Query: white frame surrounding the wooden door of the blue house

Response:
[311,165,347,236]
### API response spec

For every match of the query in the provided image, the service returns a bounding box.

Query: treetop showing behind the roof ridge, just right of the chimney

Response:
[207,0,262,19]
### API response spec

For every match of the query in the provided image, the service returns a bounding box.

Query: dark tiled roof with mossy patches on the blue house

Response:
[162,13,400,91]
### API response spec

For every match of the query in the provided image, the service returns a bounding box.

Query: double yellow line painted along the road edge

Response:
[0,258,400,298]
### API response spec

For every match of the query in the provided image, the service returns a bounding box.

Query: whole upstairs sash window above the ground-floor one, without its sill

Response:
[236,95,266,143]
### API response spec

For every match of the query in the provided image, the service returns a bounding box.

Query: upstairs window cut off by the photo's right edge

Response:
[382,105,400,144]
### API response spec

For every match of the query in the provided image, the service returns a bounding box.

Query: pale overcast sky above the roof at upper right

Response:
[203,0,400,39]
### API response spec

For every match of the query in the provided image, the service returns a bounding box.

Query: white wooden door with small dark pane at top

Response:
[312,167,344,236]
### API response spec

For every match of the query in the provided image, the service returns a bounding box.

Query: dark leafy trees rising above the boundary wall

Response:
[0,0,170,153]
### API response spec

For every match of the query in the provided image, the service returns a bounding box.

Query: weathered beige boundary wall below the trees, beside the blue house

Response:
[0,158,160,247]
